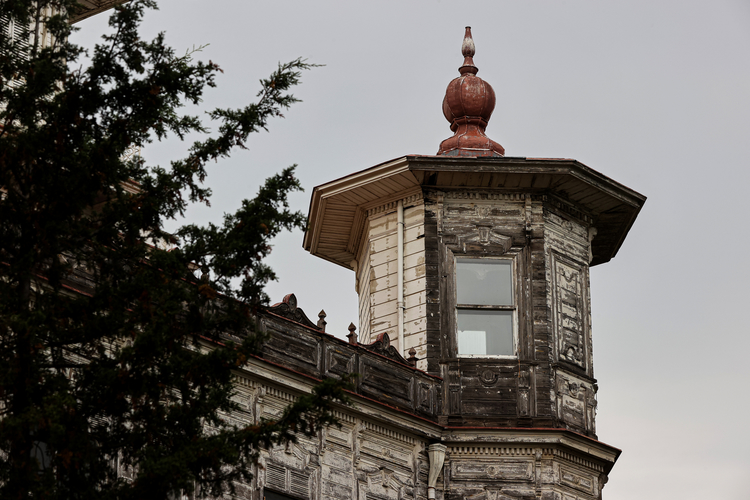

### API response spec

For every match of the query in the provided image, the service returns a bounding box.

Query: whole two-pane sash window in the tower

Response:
[456,258,516,356]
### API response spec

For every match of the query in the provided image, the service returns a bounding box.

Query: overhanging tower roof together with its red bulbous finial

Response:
[303,27,646,269]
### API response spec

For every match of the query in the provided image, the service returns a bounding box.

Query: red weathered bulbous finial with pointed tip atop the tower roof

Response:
[438,26,505,156]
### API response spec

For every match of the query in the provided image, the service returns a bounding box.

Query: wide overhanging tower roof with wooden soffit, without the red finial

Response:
[303,156,646,268]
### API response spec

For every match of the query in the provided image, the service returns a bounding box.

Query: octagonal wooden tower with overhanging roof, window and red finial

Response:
[304,28,645,499]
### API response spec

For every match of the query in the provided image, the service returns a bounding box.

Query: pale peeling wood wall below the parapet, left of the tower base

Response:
[233,373,429,500]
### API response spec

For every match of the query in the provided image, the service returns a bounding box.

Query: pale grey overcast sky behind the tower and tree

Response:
[76,0,750,500]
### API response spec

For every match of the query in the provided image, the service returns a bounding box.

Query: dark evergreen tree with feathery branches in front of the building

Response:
[0,0,347,499]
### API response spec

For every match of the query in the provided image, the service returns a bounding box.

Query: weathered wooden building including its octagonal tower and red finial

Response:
[231,28,645,500]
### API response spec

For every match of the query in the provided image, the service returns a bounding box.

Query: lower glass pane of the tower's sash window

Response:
[456,309,516,356]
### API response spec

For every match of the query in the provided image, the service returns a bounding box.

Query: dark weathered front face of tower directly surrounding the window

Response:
[430,190,536,426]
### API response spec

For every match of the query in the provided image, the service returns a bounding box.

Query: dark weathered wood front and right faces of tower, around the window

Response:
[424,189,596,436]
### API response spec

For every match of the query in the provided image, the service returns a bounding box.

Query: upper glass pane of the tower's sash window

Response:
[456,259,513,306]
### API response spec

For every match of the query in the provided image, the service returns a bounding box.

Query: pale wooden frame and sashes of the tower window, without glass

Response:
[451,252,519,360]
